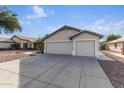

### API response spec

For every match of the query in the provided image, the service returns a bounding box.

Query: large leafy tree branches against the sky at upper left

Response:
[0,7,22,34]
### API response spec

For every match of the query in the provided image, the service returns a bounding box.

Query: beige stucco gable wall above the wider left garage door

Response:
[45,30,79,41]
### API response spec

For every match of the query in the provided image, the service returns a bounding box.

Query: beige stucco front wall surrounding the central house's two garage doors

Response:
[44,30,99,57]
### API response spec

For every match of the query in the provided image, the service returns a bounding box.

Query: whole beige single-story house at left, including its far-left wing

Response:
[0,35,37,49]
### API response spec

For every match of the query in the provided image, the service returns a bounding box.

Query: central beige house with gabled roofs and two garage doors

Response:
[44,25,102,57]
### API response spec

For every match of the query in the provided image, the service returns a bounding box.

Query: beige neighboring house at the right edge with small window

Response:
[106,38,124,52]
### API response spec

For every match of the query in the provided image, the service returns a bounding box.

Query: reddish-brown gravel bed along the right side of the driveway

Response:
[98,54,124,88]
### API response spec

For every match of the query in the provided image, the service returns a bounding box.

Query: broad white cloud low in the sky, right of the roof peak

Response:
[84,18,124,35]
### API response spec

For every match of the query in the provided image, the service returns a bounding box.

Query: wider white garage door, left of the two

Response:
[46,42,72,54]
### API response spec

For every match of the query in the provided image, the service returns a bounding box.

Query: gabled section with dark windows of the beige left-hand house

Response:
[11,35,36,49]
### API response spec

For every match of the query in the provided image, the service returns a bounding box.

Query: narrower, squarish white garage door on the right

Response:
[75,40,95,56]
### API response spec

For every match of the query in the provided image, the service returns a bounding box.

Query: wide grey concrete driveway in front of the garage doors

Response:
[0,54,113,88]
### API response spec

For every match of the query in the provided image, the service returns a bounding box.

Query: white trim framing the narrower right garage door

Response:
[73,39,98,57]
